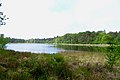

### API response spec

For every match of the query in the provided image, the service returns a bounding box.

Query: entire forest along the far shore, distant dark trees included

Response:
[7,30,120,44]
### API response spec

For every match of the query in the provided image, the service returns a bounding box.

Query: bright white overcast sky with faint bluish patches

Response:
[0,0,120,39]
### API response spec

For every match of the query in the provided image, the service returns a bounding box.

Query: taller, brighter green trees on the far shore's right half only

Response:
[55,30,120,44]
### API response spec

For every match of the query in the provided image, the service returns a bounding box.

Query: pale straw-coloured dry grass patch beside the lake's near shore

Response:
[60,51,106,64]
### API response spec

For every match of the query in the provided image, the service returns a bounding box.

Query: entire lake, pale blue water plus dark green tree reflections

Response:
[6,43,116,54]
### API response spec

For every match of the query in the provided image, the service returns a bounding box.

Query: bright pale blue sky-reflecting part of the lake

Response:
[6,43,64,53]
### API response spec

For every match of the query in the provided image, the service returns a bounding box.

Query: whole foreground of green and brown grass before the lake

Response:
[0,50,120,80]
